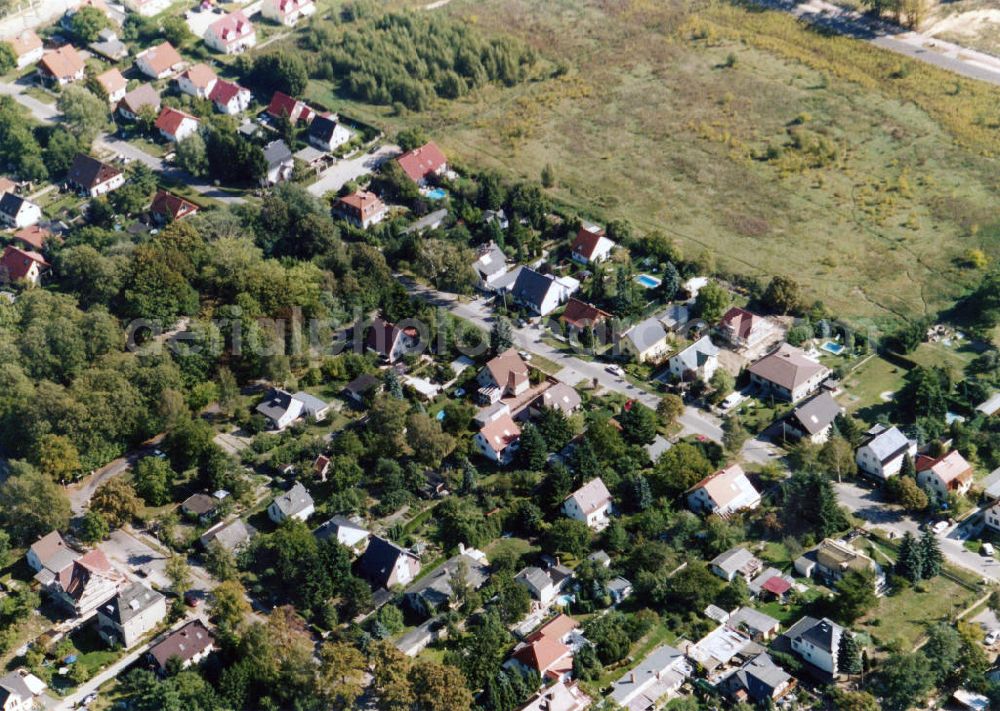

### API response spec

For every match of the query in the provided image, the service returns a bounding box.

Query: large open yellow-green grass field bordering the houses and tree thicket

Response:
[296,0,1000,325]
